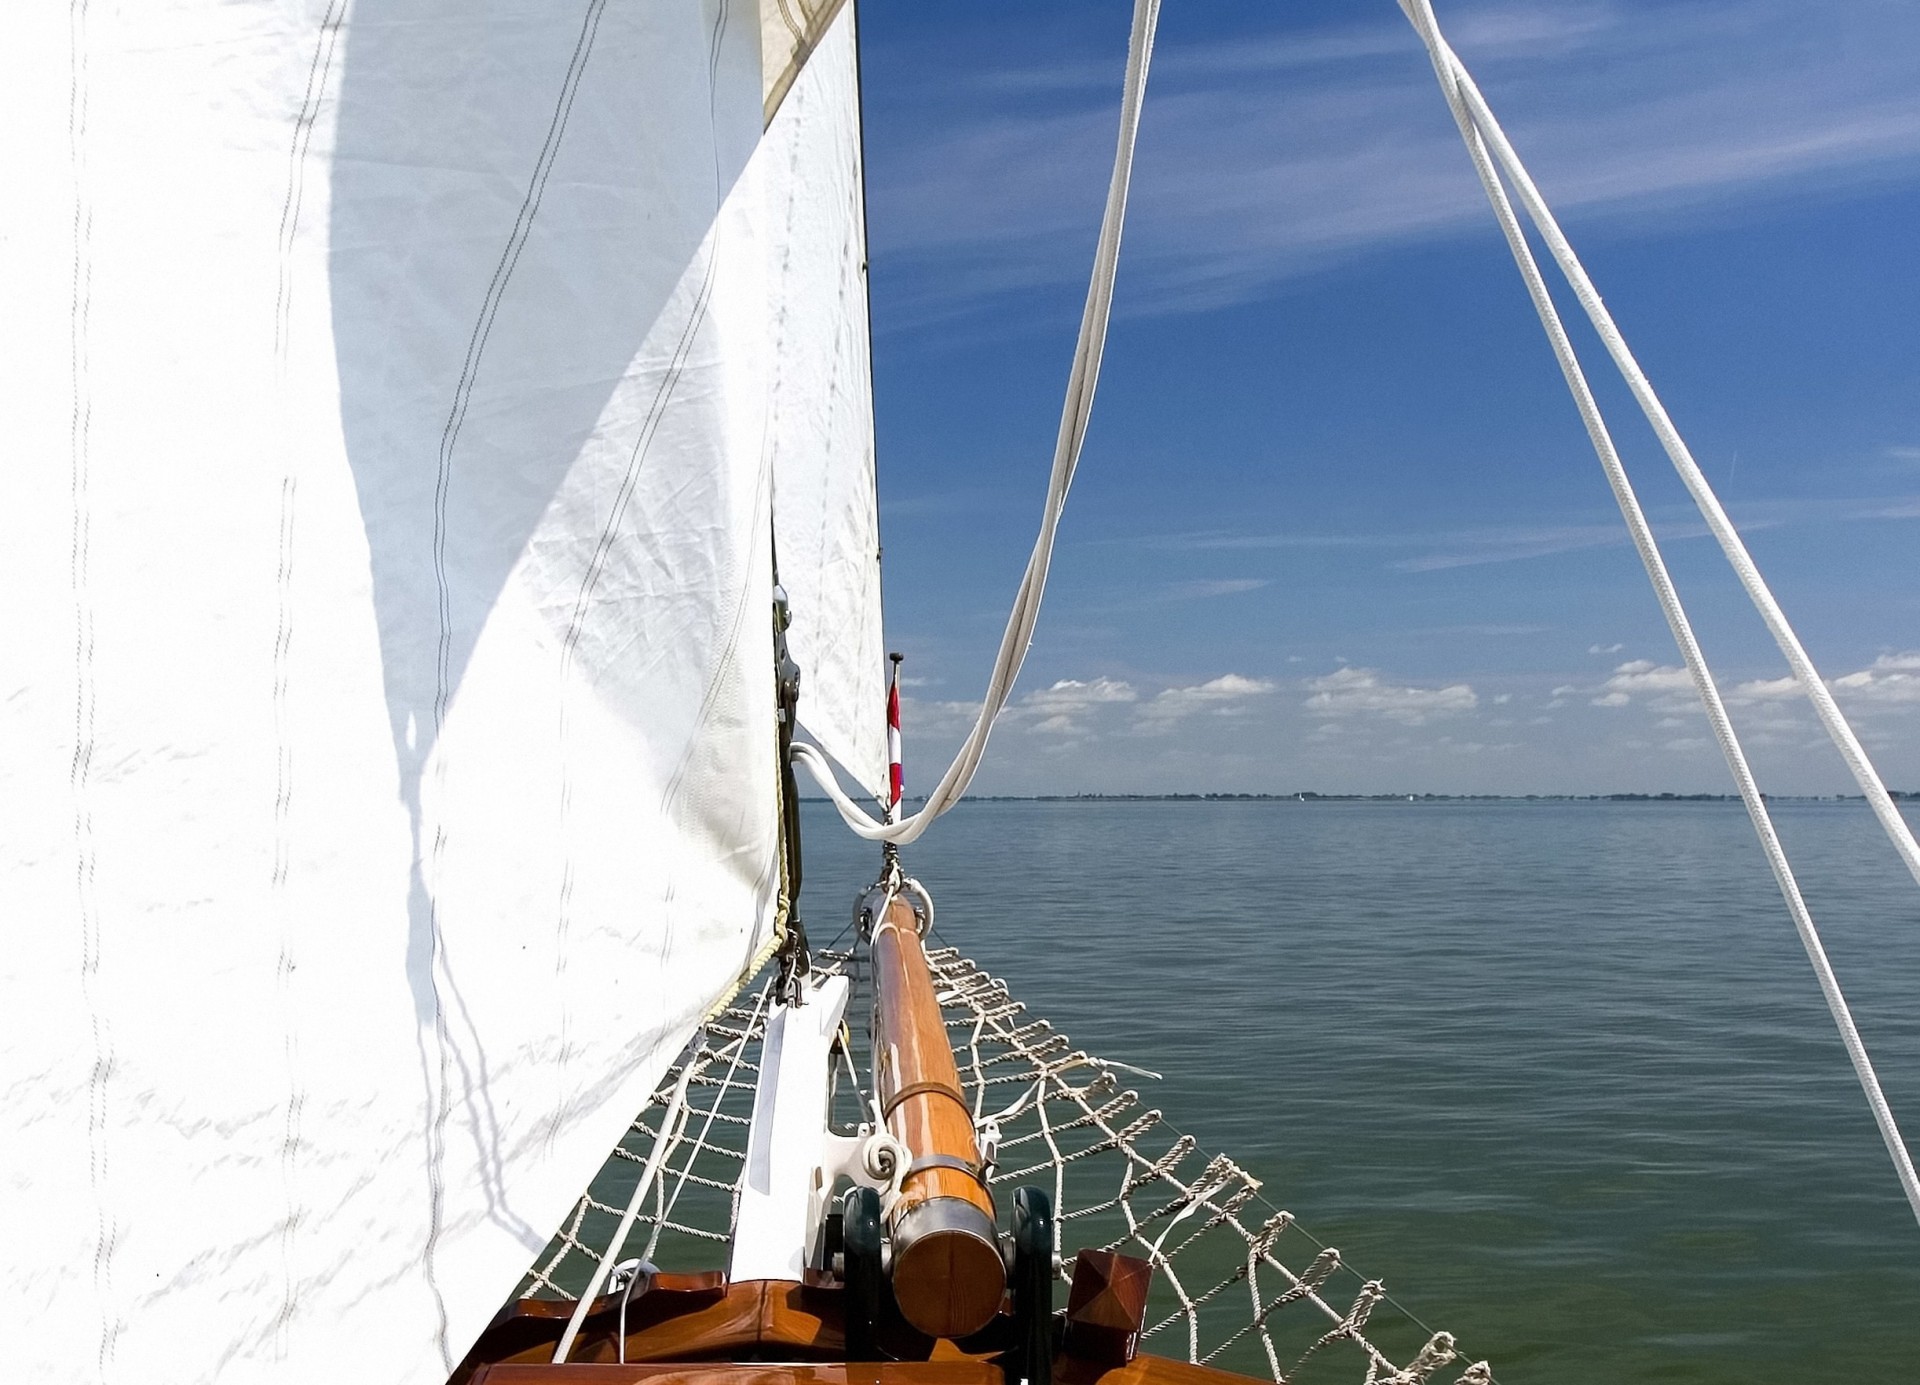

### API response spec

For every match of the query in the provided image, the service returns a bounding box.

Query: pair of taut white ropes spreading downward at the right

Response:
[1400,0,1920,1220]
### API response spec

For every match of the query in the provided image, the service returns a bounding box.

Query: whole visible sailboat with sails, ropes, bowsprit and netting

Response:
[0,0,1920,1385]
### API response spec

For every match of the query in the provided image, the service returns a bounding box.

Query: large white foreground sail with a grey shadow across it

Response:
[0,0,877,1383]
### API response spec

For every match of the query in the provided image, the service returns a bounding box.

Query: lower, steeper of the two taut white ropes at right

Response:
[1400,0,1920,1220]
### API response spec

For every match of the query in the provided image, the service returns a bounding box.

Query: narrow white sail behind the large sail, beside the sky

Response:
[762,6,887,797]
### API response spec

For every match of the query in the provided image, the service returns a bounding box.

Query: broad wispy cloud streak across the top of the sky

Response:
[874,0,1920,324]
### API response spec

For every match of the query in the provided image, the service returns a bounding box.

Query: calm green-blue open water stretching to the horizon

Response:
[804,801,1920,1385]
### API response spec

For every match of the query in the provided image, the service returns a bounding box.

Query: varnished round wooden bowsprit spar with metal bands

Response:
[872,899,1006,1337]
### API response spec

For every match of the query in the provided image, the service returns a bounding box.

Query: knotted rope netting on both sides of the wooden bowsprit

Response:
[520,947,1494,1385]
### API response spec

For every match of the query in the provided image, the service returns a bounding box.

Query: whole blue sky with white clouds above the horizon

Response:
[860,0,1920,793]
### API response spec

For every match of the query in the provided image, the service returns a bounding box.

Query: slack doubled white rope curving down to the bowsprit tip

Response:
[793,0,1160,845]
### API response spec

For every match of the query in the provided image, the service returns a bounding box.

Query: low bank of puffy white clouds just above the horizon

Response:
[887,644,1920,793]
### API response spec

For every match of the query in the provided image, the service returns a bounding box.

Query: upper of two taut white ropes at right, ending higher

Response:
[1402,10,1920,884]
